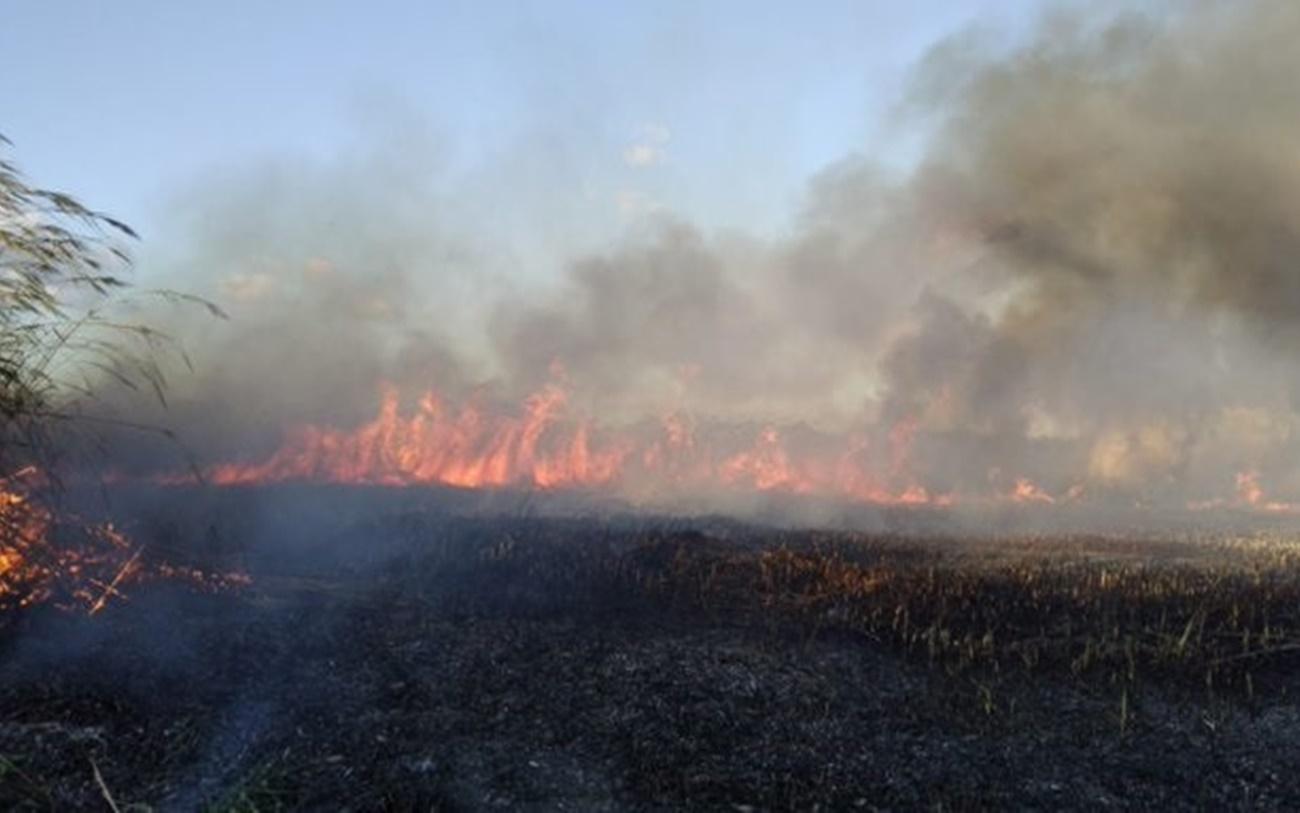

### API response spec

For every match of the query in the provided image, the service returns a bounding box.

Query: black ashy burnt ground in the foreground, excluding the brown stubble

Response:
[0,489,1300,810]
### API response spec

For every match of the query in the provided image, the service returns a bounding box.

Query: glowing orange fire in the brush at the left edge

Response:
[0,467,248,615]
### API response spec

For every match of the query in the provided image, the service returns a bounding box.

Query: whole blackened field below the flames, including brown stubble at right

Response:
[0,486,1300,810]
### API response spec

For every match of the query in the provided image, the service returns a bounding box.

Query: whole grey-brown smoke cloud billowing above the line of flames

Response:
[114,0,1300,505]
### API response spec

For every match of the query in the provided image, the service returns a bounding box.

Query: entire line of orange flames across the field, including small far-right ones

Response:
[189,384,1300,513]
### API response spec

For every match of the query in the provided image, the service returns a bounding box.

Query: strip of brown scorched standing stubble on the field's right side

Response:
[641,536,1300,696]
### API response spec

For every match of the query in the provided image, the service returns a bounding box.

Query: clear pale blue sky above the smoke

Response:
[0,0,1043,266]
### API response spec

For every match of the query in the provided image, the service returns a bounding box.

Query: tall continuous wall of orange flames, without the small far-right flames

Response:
[197,384,943,505]
